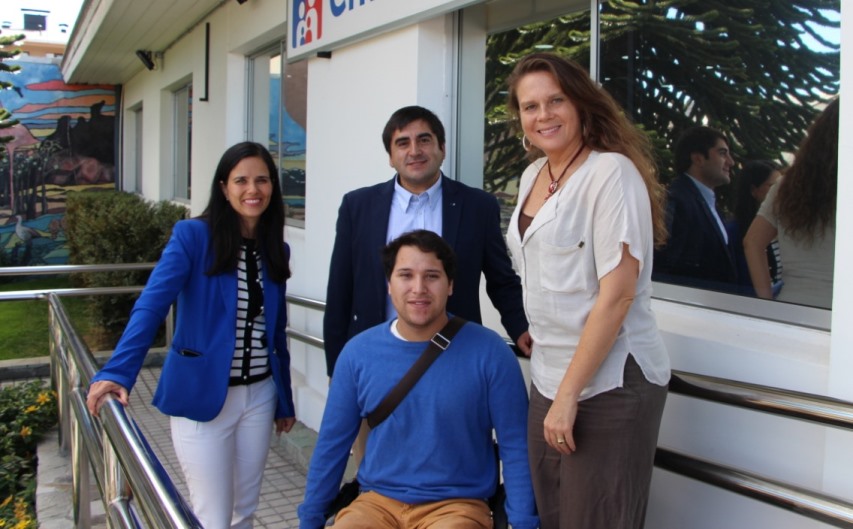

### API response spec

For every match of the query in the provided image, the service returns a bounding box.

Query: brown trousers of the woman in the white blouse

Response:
[527,355,667,529]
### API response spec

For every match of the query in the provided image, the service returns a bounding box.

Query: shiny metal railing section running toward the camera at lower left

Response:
[48,294,201,528]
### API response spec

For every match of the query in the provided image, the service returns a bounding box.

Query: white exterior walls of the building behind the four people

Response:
[115,0,853,529]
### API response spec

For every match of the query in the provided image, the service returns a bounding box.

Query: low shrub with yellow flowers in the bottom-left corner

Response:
[0,382,57,529]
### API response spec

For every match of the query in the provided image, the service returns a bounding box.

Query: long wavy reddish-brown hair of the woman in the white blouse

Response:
[507,53,667,246]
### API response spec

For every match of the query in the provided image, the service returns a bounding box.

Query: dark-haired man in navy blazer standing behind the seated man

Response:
[323,106,530,376]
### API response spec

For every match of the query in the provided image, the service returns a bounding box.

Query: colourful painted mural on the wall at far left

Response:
[0,58,116,266]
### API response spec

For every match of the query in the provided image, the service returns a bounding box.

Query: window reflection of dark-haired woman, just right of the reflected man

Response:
[728,160,782,293]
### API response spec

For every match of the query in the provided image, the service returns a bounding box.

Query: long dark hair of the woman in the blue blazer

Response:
[199,141,290,283]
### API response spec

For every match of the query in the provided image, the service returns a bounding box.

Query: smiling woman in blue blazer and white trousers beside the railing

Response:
[87,142,295,529]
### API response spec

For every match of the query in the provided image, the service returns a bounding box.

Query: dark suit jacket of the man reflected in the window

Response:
[653,174,737,290]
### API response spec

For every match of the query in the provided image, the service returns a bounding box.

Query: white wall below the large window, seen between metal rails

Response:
[647,302,832,529]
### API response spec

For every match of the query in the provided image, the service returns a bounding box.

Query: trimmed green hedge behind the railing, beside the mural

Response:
[65,191,187,343]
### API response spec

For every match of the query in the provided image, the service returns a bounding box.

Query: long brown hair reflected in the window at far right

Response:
[773,97,840,244]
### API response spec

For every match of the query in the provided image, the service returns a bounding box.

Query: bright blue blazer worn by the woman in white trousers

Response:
[92,219,295,421]
